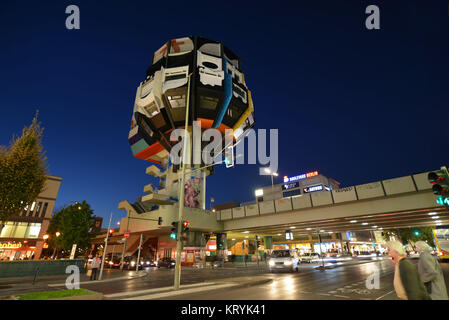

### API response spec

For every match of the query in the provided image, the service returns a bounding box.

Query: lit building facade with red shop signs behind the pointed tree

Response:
[0,175,62,260]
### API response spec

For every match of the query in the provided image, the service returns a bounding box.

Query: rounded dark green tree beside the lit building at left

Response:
[47,201,93,258]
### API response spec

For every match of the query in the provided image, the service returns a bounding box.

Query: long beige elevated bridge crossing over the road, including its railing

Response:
[216,172,449,234]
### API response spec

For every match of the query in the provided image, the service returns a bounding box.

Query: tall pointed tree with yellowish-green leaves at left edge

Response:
[0,112,47,232]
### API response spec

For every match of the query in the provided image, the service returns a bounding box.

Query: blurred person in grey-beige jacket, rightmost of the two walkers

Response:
[415,241,449,300]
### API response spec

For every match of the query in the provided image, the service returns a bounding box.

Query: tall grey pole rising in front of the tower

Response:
[174,74,192,290]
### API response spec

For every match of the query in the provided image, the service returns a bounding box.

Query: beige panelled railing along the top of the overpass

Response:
[217,172,432,221]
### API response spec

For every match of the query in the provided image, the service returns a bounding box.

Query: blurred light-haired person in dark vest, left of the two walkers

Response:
[386,241,431,300]
